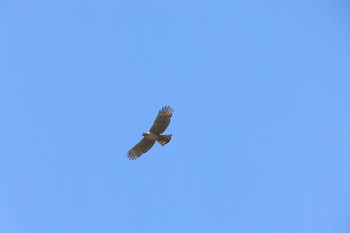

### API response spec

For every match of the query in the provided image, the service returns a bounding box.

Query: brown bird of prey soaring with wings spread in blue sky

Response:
[128,106,174,160]
